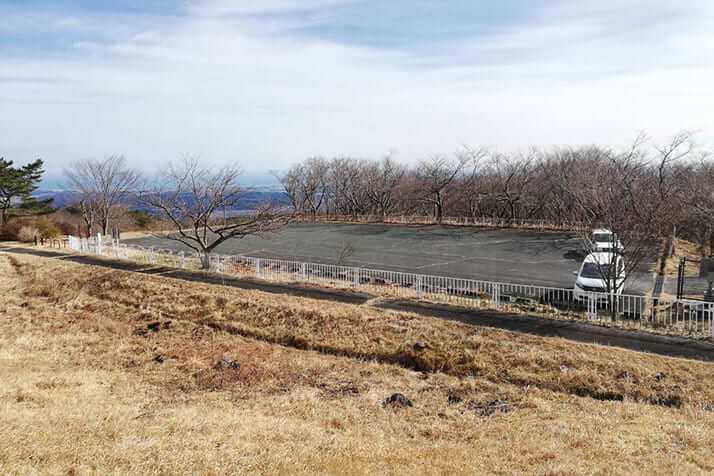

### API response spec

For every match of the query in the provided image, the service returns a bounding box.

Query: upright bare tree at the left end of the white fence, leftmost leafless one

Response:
[64,155,139,235]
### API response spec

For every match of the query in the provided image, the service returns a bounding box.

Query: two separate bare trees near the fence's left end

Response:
[65,155,291,268]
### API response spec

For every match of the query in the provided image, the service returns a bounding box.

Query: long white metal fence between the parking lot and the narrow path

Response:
[69,236,714,337]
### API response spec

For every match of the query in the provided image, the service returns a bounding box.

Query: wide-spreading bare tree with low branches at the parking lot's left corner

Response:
[138,159,292,268]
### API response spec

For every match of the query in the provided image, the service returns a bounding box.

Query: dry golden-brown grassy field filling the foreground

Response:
[0,254,714,474]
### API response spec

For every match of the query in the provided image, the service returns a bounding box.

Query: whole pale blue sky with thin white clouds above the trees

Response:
[0,0,714,184]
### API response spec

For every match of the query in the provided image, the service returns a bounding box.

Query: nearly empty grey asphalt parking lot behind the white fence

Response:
[124,223,652,294]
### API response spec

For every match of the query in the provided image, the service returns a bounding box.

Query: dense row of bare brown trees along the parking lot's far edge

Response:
[278,133,714,253]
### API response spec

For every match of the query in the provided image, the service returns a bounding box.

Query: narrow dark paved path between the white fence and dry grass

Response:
[0,246,714,362]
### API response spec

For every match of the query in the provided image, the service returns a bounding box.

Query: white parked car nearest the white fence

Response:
[573,252,625,300]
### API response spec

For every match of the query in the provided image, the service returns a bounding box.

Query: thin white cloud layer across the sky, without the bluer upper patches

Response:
[0,0,714,180]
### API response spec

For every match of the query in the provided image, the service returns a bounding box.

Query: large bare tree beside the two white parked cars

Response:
[564,135,691,293]
